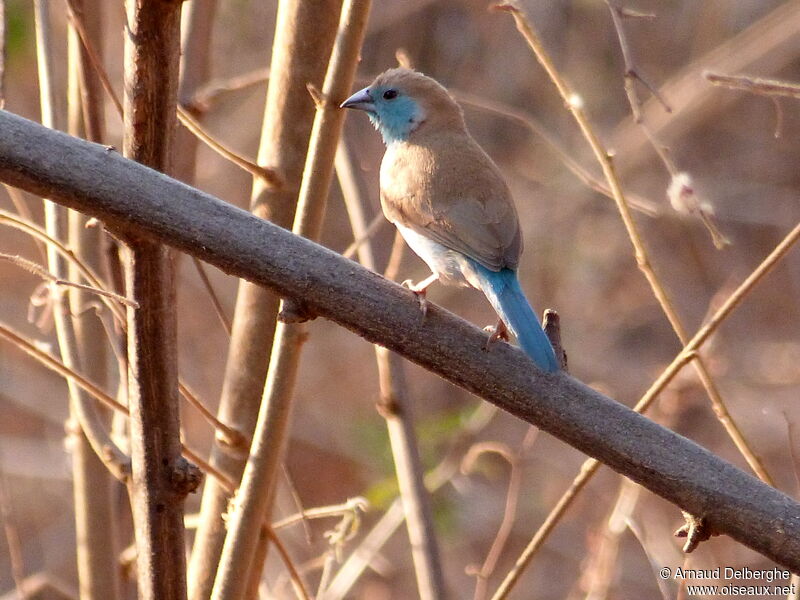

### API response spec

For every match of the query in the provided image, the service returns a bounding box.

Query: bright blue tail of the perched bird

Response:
[470,260,559,373]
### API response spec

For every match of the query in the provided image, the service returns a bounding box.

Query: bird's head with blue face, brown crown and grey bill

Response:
[341,68,464,145]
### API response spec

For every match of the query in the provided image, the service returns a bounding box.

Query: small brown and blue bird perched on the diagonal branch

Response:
[341,68,559,372]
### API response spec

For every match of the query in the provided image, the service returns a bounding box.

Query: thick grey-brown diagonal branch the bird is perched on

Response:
[0,112,800,572]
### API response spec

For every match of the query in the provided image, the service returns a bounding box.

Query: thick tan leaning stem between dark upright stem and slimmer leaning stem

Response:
[189,0,341,600]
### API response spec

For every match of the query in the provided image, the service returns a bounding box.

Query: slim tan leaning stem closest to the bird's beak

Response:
[212,0,370,600]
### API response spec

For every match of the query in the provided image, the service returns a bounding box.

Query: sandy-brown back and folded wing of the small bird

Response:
[381,134,522,271]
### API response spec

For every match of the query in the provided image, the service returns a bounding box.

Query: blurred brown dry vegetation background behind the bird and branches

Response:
[0,0,800,600]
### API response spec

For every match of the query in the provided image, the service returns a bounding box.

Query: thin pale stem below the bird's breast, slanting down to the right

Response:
[336,142,445,600]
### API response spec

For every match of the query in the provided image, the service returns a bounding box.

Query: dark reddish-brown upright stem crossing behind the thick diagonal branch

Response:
[123,0,199,600]
